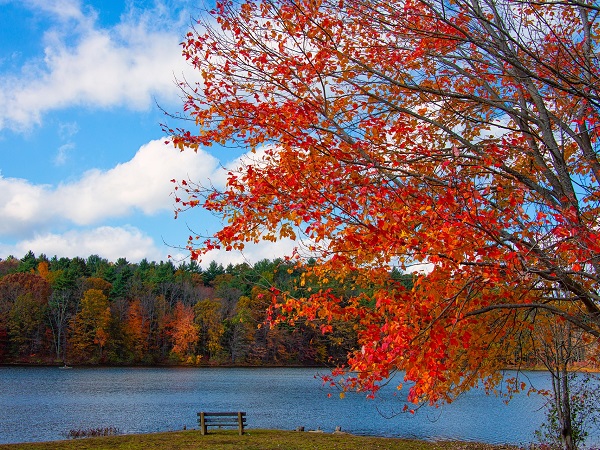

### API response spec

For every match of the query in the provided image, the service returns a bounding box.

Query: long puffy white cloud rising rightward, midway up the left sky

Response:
[0,140,219,238]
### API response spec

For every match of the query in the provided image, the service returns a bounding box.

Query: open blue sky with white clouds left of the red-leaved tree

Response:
[0,0,293,266]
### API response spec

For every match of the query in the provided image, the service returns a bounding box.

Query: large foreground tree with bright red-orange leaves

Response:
[167,0,600,402]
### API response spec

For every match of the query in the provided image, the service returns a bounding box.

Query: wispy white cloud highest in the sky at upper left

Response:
[0,0,195,131]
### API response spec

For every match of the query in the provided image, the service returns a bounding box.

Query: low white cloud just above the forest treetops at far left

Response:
[0,226,166,262]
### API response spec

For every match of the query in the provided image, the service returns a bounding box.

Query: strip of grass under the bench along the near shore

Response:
[0,429,516,450]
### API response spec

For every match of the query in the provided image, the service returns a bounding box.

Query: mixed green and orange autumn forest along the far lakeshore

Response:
[0,252,411,365]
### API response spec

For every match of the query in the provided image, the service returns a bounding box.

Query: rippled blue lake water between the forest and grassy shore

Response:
[0,367,600,444]
